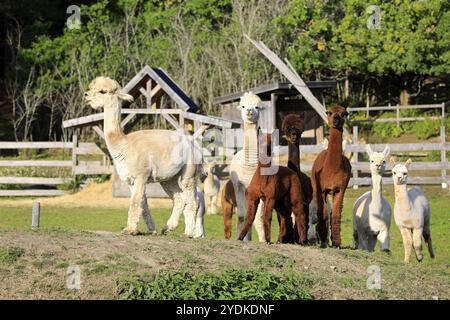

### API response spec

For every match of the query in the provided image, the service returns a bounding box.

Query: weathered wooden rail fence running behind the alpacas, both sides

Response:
[0,127,450,197]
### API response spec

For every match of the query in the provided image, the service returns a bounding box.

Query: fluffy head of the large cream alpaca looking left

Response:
[84,77,133,109]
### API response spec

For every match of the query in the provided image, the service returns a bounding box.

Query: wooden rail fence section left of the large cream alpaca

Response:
[0,135,112,196]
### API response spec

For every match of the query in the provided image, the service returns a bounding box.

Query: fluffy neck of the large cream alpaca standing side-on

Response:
[103,96,125,147]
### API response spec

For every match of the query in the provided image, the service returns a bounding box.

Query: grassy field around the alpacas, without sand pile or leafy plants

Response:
[0,186,450,299]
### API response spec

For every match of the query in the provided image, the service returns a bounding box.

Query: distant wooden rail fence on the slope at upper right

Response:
[347,103,445,128]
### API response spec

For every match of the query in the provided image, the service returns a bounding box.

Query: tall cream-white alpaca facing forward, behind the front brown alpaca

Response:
[230,92,265,242]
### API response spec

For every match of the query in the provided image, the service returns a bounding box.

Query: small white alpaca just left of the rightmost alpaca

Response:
[353,145,391,252]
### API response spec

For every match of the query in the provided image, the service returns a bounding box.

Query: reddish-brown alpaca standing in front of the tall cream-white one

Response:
[238,135,306,245]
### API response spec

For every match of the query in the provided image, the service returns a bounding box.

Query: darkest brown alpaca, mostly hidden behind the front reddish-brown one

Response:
[282,114,313,242]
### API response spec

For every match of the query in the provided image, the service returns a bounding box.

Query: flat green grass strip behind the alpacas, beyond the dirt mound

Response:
[0,186,450,265]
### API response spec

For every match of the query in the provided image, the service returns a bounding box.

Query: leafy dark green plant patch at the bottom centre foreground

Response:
[117,269,313,300]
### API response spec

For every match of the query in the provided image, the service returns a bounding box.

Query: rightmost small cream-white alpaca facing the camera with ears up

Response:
[391,158,434,263]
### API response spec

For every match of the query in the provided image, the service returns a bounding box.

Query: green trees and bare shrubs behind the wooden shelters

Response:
[0,0,450,140]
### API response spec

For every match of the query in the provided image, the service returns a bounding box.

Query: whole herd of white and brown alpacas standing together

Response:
[85,77,434,263]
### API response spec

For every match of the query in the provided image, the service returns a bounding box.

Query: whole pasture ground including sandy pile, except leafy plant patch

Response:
[0,183,450,299]
